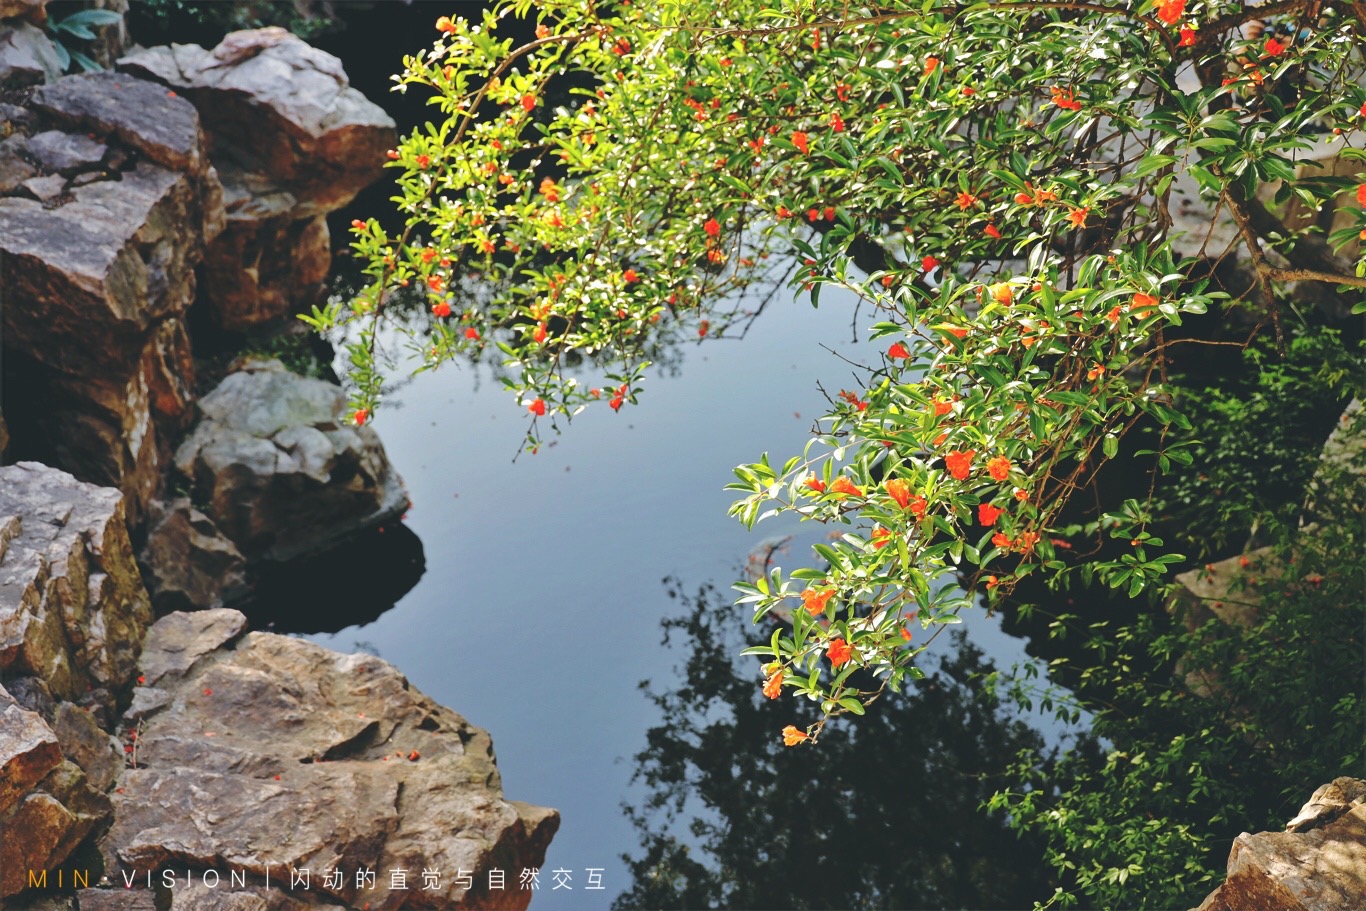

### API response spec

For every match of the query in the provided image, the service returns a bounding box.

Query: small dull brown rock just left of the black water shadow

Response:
[138,497,246,613]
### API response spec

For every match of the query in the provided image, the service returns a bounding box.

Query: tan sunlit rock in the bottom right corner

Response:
[1197,779,1366,911]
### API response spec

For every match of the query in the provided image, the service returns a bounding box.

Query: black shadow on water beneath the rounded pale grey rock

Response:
[234,522,426,634]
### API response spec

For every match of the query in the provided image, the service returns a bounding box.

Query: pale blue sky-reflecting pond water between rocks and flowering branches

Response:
[224,3,1076,910]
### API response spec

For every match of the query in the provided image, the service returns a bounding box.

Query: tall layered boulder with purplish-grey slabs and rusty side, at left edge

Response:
[0,72,223,523]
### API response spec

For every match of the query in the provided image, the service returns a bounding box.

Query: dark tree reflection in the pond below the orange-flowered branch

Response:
[613,579,1052,910]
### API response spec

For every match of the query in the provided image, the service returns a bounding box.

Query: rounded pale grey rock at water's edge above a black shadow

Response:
[175,359,408,561]
